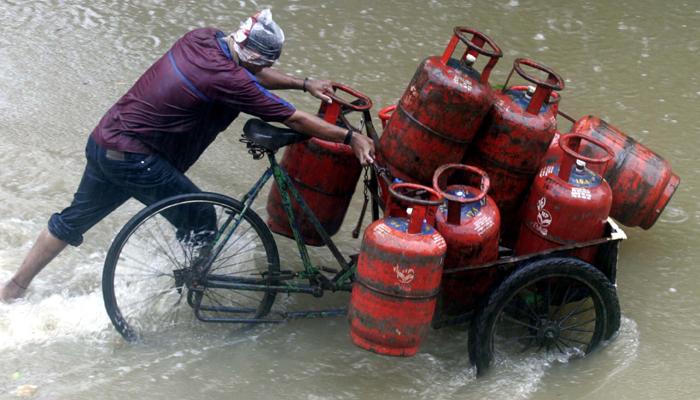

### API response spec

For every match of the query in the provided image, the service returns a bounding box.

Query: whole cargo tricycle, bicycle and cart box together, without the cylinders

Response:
[102,98,626,373]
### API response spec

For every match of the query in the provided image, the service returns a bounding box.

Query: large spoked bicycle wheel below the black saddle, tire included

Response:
[102,193,279,341]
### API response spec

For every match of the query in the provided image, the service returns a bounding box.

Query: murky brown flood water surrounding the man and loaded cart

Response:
[0,0,700,400]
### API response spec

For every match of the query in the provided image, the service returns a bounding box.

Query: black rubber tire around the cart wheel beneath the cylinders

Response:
[469,258,620,375]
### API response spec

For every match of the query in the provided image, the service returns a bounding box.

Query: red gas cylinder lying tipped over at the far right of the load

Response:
[571,115,680,229]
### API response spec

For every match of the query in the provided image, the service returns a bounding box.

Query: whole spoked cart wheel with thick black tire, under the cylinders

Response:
[469,258,620,375]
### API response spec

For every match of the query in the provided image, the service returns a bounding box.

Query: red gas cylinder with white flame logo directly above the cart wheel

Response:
[515,134,612,262]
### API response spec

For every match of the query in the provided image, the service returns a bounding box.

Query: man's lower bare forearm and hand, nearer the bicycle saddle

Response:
[284,110,374,165]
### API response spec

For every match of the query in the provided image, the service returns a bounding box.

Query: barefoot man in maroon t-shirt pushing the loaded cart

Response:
[0,10,374,301]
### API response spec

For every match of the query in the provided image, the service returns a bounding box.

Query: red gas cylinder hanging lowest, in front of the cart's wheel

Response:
[348,183,447,356]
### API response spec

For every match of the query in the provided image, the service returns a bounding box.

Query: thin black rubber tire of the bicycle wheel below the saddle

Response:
[102,192,279,341]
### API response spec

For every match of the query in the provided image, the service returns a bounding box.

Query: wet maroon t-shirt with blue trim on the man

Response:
[92,28,296,171]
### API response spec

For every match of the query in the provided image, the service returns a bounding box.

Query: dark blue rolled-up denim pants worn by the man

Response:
[48,137,200,246]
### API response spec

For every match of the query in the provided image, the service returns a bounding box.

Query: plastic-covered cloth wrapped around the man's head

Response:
[232,8,284,65]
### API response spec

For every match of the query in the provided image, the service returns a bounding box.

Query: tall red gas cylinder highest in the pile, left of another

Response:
[379,27,502,185]
